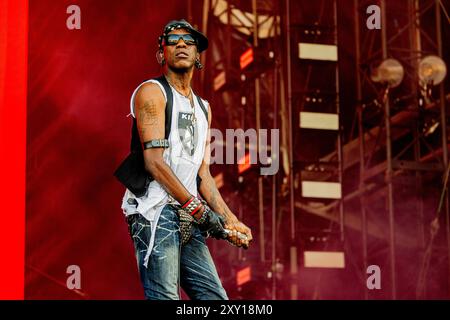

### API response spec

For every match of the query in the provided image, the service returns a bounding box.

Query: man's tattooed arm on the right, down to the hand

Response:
[198,106,253,247]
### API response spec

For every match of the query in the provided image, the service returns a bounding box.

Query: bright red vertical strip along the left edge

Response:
[0,0,28,299]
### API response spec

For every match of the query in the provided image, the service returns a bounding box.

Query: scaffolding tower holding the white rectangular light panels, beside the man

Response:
[199,0,344,299]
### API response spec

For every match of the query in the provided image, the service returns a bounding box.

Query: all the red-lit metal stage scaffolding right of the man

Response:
[194,0,450,299]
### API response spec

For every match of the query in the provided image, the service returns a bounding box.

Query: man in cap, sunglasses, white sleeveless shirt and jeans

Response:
[118,20,252,300]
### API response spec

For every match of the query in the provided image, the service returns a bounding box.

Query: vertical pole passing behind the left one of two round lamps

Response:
[381,0,397,300]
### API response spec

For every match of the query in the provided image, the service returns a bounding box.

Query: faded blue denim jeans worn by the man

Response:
[127,204,228,300]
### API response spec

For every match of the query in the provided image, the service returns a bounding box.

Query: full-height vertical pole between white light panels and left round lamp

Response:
[353,0,369,300]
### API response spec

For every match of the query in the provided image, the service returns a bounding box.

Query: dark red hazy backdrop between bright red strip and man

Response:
[25,0,193,299]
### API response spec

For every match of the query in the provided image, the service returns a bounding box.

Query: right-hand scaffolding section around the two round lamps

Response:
[352,0,450,299]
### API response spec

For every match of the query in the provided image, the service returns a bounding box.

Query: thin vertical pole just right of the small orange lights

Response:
[252,0,266,262]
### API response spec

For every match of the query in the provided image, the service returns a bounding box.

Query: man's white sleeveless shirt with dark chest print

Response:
[122,79,208,266]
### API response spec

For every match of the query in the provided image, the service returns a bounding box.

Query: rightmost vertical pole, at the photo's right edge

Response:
[435,0,450,295]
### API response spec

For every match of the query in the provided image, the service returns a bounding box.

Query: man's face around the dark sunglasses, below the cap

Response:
[164,29,198,70]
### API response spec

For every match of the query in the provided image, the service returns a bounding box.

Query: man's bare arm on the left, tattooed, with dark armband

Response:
[134,83,191,204]
